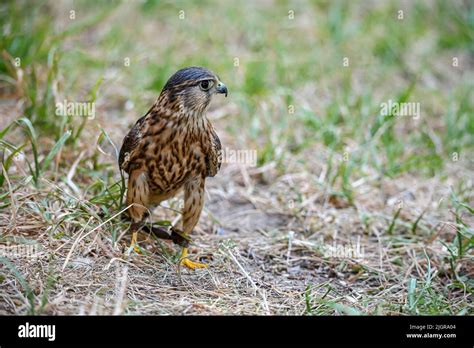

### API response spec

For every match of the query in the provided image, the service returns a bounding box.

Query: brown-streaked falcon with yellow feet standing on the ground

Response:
[119,67,227,269]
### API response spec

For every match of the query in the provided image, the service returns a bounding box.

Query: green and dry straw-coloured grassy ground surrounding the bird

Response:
[0,0,474,315]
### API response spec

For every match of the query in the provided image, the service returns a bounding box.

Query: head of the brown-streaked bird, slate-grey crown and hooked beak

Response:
[161,67,227,115]
